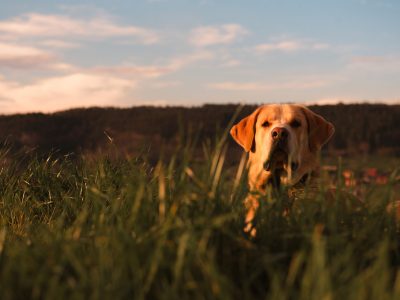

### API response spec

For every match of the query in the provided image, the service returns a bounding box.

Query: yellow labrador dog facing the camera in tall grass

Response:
[230,104,335,231]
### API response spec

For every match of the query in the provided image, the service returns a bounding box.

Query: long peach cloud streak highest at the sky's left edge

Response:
[0,13,159,44]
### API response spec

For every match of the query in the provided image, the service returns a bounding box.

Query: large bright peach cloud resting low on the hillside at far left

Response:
[0,73,136,113]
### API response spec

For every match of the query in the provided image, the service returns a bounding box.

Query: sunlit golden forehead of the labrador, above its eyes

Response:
[259,104,302,123]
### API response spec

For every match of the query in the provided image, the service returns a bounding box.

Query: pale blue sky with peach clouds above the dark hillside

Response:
[0,0,400,114]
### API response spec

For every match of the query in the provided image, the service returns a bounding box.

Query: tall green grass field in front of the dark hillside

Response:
[0,130,400,299]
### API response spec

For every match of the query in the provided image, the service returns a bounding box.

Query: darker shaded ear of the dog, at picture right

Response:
[302,107,335,152]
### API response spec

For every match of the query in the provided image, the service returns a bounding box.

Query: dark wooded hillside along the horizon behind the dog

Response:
[0,104,400,159]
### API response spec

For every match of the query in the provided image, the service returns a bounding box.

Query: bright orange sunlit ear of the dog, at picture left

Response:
[230,108,260,152]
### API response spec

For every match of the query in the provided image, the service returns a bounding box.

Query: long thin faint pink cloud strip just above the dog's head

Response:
[208,79,330,91]
